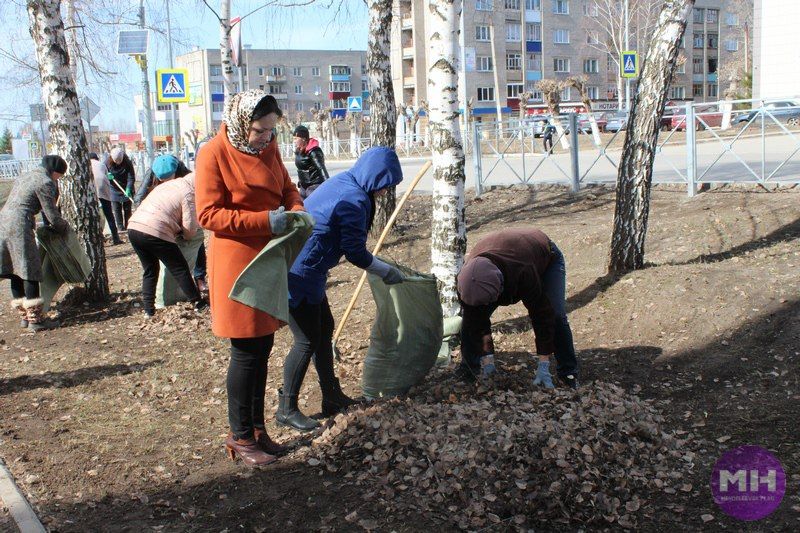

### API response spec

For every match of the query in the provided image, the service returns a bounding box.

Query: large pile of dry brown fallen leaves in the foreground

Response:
[308,376,694,529]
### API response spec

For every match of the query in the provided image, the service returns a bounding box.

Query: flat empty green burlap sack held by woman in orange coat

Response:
[228,211,314,322]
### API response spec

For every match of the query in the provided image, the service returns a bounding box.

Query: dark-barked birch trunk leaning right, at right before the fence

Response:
[608,0,694,273]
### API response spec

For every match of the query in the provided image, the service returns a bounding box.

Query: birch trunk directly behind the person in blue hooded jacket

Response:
[367,0,397,237]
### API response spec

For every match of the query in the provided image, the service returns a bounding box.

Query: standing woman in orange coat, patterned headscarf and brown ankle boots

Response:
[195,90,303,466]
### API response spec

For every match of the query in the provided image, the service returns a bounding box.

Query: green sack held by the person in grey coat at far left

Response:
[36,226,92,311]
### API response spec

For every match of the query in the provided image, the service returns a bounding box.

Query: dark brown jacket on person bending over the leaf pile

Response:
[469,228,555,354]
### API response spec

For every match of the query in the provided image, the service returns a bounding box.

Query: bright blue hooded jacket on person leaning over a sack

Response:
[289,147,403,308]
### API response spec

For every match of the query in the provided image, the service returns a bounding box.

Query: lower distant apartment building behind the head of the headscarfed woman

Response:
[176,46,369,136]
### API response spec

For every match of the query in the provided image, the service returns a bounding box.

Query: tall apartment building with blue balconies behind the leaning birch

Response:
[391,0,752,115]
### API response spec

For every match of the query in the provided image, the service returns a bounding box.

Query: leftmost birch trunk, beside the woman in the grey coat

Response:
[27,0,108,301]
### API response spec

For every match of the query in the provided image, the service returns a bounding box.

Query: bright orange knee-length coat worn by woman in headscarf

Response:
[195,125,303,338]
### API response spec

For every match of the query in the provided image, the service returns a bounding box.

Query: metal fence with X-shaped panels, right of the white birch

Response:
[472,97,800,195]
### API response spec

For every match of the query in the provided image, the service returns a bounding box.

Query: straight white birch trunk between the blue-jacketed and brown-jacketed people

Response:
[428,0,467,317]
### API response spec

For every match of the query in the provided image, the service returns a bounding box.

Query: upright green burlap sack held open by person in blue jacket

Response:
[361,259,443,399]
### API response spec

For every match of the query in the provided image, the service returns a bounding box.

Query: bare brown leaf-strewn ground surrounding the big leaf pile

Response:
[0,188,800,531]
